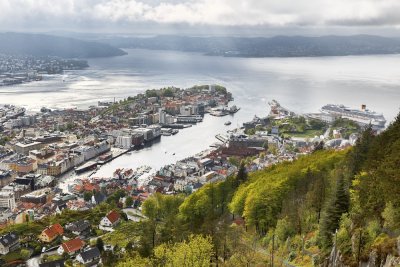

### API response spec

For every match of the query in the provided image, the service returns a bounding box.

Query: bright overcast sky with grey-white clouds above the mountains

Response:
[0,0,400,33]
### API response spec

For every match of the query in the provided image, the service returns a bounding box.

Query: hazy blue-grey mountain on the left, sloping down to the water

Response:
[0,32,126,58]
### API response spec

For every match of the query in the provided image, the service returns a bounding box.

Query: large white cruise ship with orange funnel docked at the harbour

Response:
[321,104,386,129]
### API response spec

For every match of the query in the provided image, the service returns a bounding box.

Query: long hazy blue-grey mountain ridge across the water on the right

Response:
[102,35,400,57]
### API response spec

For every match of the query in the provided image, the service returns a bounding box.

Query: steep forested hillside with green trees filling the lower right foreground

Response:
[111,112,400,266]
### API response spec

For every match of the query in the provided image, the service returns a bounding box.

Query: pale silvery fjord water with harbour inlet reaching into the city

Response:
[0,49,400,175]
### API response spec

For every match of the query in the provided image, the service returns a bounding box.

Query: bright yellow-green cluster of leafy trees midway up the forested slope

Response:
[229,151,344,236]
